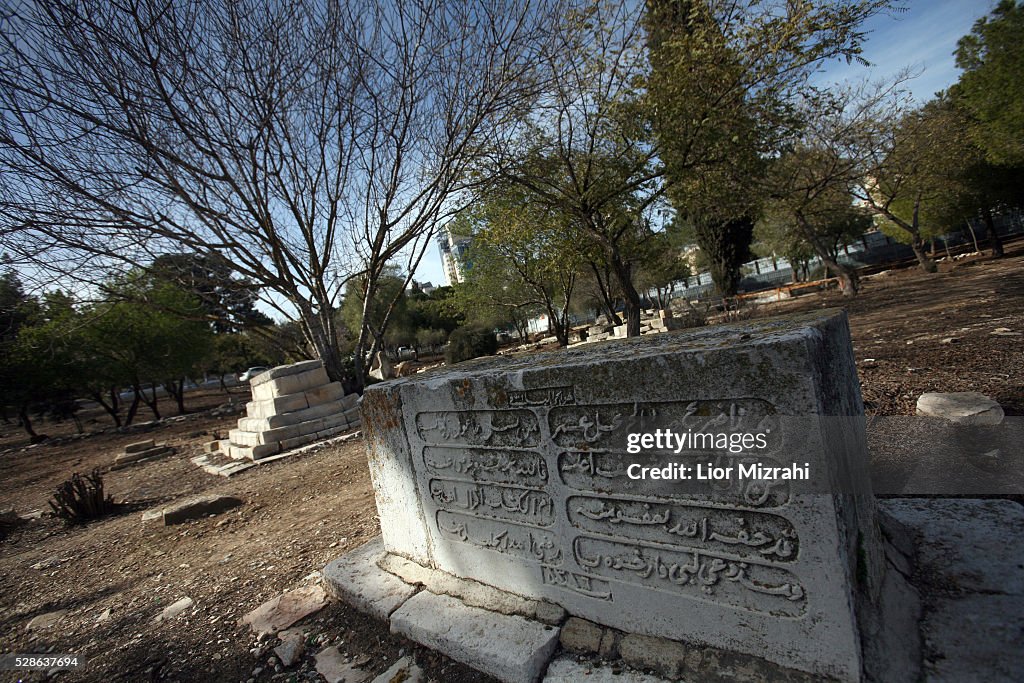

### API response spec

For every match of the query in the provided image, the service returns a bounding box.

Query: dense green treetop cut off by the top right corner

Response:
[954,0,1024,166]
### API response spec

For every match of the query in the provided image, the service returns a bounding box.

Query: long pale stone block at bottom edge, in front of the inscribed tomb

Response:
[391,591,558,683]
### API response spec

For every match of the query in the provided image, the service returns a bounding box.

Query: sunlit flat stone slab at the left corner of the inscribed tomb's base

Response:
[324,537,419,621]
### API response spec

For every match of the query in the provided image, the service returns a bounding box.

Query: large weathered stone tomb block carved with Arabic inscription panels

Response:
[361,312,885,681]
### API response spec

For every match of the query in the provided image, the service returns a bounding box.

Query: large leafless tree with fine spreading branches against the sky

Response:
[0,0,549,385]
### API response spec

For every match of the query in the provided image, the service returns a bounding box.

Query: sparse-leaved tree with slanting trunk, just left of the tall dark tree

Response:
[489,1,663,336]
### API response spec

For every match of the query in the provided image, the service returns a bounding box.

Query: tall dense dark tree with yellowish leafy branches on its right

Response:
[646,0,887,295]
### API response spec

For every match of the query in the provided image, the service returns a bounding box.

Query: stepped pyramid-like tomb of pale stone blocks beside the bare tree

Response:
[221,360,360,460]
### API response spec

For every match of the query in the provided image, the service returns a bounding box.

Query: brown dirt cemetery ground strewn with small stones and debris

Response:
[0,242,1024,683]
